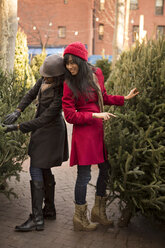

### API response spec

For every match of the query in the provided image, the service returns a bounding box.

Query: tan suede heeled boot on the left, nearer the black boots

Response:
[73,204,97,232]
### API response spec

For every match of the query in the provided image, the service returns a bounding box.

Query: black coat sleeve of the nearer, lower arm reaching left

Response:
[20,96,62,133]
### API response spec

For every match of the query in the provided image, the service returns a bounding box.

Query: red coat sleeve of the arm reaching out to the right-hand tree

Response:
[96,68,124,106]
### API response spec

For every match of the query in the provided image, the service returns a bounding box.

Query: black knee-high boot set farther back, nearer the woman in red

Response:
[43,174,56,220]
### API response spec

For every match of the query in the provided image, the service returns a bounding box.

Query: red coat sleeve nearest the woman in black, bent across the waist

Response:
[62,83,93,125]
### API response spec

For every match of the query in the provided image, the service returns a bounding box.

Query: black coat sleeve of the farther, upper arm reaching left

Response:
[17,78,42,112]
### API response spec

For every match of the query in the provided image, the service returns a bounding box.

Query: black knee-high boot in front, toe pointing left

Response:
[15,181,44,232]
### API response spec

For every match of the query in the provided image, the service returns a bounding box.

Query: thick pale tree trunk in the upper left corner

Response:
[0,0,18,72]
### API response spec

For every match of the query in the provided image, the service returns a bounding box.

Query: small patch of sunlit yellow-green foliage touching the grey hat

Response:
[30,49,46,81]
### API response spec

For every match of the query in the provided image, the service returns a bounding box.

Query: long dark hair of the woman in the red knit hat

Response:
[64,54,99,98]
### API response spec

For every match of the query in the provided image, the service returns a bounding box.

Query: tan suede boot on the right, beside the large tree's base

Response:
[91,195,114,226]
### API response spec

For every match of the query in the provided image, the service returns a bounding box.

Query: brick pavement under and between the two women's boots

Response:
[0,122,165,248]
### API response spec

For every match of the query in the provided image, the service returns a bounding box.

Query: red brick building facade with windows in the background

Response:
[18,0,165,59]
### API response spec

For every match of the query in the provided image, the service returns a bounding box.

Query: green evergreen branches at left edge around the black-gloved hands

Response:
[0,72,34,196]
